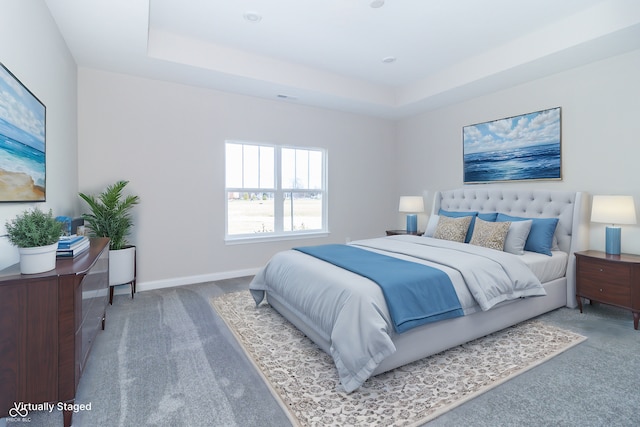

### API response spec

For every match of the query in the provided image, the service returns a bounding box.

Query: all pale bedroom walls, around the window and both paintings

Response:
[0,0,640,289]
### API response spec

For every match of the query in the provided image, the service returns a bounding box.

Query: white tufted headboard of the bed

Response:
[432,188,589,307]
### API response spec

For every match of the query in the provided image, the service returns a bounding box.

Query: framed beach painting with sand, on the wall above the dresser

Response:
[0,63,46,202]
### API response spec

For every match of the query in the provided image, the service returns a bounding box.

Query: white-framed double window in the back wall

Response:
[226,141,327,240]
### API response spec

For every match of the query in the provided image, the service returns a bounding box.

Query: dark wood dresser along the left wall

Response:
[0,238,109,426]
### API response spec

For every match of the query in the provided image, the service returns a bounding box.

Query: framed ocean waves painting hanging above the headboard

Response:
[462,107,562,184]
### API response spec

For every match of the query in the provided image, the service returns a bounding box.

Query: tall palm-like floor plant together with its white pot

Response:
[79,181,140,289]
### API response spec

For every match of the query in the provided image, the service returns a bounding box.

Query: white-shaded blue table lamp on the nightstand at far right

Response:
[591,196,636,255]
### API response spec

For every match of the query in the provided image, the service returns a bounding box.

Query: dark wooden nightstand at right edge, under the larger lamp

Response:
[576,251,640,329]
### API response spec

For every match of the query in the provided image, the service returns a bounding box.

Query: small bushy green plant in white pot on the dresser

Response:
[5,208,63,274]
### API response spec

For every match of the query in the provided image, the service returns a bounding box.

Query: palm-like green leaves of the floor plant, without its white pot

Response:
[79,181,140,250]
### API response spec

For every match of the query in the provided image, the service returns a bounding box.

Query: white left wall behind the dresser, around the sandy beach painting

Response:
[0,0,78,269]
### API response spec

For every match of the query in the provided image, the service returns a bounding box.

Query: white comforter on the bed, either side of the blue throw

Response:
[250,236,545,392]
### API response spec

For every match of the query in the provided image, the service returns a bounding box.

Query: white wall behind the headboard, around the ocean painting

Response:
[398,51,640,253]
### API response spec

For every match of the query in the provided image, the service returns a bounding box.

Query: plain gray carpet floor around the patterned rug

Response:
[5,278,640,427]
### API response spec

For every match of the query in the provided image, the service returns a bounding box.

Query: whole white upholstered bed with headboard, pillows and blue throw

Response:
[250,188,588,392]
